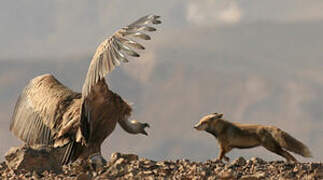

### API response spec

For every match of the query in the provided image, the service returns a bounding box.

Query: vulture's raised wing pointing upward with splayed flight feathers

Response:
[82,15,161,99]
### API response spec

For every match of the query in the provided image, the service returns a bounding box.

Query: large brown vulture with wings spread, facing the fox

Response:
[10,15,161,164]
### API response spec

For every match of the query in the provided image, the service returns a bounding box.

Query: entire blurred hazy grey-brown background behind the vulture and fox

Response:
[0,0,323,161]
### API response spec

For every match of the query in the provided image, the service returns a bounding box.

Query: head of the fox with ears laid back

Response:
[194,113,223,131]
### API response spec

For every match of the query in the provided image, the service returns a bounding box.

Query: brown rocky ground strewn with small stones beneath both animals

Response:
[0,153,323,180]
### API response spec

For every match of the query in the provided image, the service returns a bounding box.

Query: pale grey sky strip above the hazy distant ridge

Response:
[0,0,323,61]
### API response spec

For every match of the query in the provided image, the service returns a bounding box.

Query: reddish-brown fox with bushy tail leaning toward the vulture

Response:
[194,113,313,162]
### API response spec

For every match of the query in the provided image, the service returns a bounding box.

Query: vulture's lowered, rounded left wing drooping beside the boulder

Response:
[10,74,80,146]
